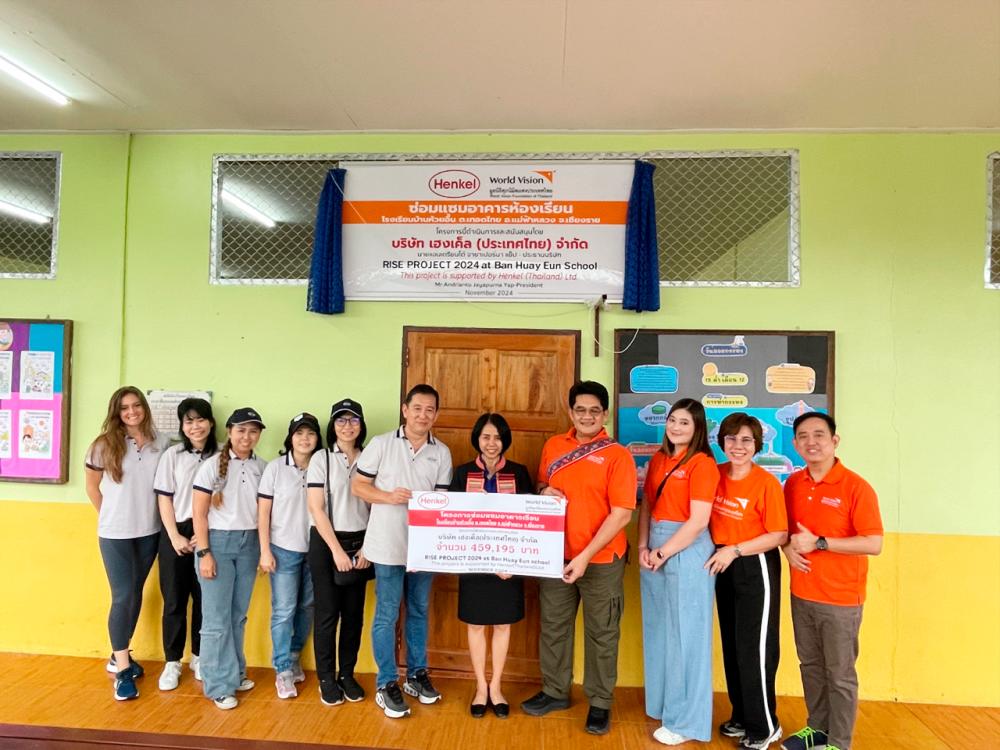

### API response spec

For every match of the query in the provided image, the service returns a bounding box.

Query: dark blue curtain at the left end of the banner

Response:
[306,169,347,315]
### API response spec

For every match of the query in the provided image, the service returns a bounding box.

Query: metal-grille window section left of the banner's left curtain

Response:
[211,155,337,284]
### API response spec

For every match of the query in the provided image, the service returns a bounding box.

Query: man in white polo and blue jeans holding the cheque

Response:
[351,383,451,719]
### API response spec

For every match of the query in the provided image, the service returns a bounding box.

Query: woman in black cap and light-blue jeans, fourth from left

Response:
[257,412,323,698]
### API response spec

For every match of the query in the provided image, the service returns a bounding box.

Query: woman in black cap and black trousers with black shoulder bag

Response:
[307,398,375,706]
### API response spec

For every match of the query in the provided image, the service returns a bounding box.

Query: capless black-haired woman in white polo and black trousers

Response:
[153,398,219,690]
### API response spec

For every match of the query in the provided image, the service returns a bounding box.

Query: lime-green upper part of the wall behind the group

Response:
[9,134,1000,534]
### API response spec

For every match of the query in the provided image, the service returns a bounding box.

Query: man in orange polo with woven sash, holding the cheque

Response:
[521,380,636,734]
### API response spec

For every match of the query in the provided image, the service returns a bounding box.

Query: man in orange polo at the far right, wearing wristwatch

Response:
[781,412,882,750]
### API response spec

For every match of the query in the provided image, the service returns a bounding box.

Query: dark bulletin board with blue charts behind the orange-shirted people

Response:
[615,329,834,488]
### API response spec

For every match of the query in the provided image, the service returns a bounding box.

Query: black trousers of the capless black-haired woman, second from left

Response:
[160,519,201,661]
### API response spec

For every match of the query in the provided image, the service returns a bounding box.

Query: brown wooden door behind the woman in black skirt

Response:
[402,328,580,680]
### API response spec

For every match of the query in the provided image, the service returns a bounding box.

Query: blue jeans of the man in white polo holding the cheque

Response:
[372,563,434,688]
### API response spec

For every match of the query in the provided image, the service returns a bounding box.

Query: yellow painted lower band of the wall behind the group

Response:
[0,501,1000,706]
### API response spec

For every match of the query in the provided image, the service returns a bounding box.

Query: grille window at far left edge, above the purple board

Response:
[0,151,60,279]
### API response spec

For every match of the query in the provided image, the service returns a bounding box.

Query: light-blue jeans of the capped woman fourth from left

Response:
[271,544,313,672]
